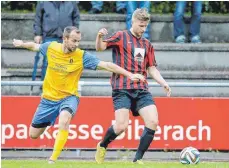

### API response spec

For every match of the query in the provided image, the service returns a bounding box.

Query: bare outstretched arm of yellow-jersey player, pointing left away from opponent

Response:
[13,39,40,51]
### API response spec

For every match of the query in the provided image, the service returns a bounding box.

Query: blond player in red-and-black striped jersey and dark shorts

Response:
[95,8,171,164]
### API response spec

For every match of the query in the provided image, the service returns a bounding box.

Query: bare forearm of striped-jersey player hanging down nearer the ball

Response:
[148,66,171,97]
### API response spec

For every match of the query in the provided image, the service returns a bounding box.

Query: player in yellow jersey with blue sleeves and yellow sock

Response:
[13,26,145,163]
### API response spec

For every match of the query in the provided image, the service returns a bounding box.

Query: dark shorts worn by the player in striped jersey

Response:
[112,89,155,116]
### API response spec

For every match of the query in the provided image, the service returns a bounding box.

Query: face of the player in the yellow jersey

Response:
[64,31,81,52]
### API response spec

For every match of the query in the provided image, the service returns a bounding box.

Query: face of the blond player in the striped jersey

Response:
[132,19,149,38]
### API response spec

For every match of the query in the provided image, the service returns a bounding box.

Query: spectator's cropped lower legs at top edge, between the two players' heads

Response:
[89,1,126,14]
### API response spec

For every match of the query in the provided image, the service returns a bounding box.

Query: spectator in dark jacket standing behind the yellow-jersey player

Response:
[31,1,80,90]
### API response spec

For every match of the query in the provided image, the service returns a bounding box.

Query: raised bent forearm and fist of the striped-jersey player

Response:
[95,28,108,51]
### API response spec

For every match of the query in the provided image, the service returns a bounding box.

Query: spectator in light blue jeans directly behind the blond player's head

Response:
[126,1,150,41]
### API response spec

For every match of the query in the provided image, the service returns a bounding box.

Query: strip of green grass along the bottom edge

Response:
[1,160,229,168]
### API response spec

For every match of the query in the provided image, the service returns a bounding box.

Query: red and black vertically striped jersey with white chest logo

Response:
[104,30,157,89]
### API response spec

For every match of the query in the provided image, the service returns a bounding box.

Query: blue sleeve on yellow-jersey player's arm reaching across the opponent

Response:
[83,51,100,70]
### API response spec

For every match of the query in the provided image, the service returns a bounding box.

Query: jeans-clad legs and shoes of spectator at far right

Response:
[174,1,202,43]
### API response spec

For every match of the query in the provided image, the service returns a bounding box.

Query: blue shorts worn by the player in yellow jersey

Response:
[32,96,79,128]
